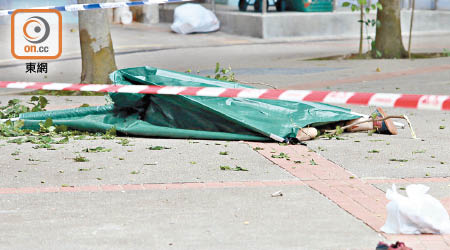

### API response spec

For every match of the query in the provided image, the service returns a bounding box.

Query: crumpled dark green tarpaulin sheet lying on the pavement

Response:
[20,67,360,141]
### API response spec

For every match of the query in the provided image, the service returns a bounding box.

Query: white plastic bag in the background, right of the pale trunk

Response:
[170,3,220,34]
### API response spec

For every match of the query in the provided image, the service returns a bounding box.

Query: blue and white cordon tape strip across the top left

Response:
[0,0,191,16]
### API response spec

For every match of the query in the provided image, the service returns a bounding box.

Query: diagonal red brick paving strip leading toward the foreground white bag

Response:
[248,142,450,250]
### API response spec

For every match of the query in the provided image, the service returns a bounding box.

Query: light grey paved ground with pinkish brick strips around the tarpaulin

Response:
[0,22,450,250]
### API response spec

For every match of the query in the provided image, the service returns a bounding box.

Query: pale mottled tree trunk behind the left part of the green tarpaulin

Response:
[78,0,117,84]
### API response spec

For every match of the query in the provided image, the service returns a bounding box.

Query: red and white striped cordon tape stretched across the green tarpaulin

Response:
[0,81,450,110]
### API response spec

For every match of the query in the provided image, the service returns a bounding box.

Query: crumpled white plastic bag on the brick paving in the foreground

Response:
[381,184,450,234]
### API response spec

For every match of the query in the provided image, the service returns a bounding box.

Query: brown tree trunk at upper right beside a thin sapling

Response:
[373,0,408,58]
